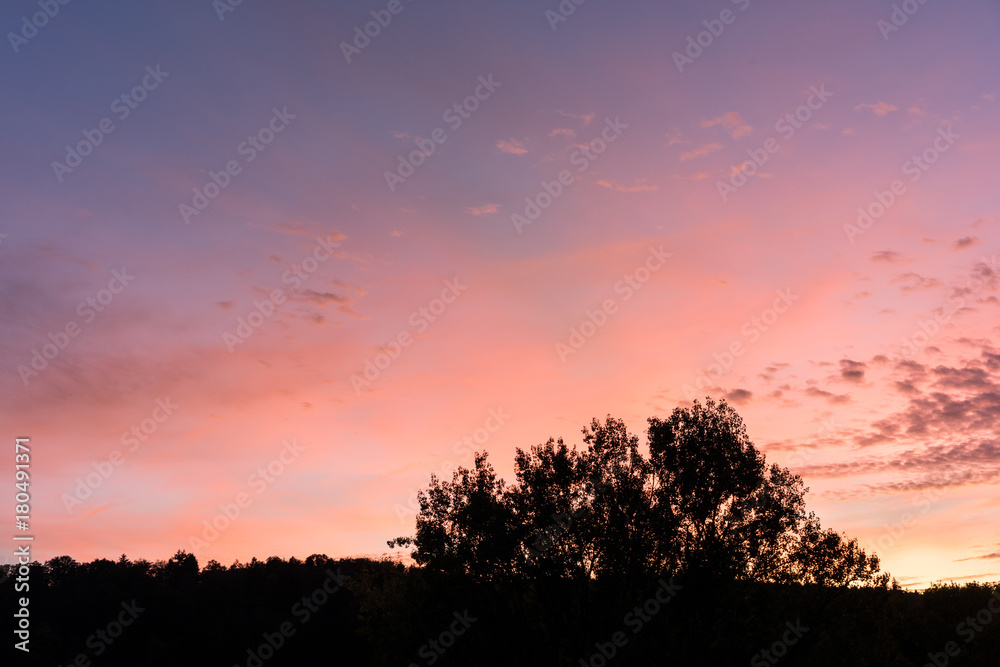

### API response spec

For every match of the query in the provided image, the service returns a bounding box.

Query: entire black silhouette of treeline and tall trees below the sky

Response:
[2,401,1000,667]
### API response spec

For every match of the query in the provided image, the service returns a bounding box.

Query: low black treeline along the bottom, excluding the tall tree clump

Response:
[2,552,1000,667]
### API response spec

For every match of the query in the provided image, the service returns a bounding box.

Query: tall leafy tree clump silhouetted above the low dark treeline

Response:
[389,399,888,586]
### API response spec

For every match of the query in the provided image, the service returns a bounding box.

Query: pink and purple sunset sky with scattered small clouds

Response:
[0,0,1000,587]
